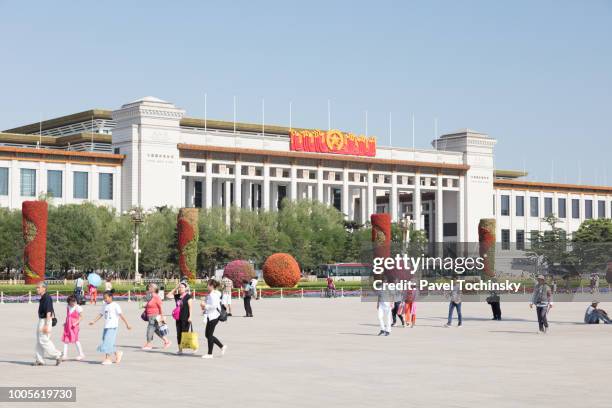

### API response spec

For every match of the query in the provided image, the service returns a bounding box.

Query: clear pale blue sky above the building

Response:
[0,0,612,185]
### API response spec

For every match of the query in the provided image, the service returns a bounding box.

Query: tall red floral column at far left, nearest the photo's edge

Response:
[21,201,49,284]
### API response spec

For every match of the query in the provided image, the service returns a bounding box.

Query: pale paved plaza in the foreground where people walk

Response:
[0,298,612,408]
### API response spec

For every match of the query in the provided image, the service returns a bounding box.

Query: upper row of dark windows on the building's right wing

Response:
[493,194,612,219]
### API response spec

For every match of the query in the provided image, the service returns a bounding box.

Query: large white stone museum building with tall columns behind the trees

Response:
[0,97,612,247]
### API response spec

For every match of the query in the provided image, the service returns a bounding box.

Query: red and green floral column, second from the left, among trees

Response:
[176,208,199,280]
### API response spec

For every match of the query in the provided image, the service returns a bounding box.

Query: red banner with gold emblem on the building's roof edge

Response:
[289,130,376,157]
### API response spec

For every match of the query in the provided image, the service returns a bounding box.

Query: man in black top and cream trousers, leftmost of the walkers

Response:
[34,282,62,366]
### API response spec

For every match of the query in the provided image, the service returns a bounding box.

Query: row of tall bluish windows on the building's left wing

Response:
[0,167,113,200]
